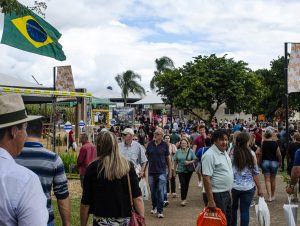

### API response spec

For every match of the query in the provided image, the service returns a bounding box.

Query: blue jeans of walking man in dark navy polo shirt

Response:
[148,173,167,213]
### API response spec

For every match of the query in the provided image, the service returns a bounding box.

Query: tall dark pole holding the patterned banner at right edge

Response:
[284,42,289,148]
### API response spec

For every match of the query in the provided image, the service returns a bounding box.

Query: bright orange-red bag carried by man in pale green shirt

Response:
[197,208,227,226]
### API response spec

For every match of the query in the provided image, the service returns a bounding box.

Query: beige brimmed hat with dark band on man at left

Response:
[0,93,42,129]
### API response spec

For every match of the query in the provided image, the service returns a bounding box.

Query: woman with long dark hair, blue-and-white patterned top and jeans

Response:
[230,132,263,226]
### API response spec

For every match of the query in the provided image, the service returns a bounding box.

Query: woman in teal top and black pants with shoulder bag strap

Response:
[173,137,197,206]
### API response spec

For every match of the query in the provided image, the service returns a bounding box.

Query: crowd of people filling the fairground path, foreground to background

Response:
[0,94,300,226]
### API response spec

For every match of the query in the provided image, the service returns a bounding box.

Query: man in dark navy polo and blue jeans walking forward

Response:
[146,128,171,218]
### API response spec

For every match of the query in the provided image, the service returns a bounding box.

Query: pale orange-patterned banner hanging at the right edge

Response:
[288,44,300,93]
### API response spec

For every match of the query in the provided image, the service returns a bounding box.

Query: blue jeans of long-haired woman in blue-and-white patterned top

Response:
[230,187,255,226]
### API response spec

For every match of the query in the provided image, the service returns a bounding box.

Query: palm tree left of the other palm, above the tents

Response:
[115,70,146,106]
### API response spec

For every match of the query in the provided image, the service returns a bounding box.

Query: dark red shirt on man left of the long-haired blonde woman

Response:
[77,142,97,176]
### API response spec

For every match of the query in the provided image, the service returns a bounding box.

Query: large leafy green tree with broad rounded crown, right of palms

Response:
[155,54,263,122]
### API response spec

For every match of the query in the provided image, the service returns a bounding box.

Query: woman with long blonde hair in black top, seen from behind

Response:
[80,131,144,226]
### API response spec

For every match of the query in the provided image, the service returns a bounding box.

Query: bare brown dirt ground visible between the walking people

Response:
[70,174,300,226]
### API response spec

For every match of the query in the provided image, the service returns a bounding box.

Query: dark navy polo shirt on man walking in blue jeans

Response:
[146,140,170,174]
